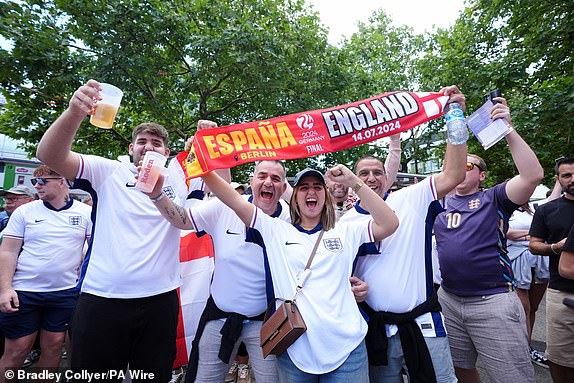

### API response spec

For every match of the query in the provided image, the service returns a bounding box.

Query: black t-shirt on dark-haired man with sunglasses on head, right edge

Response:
[528,197,574,293]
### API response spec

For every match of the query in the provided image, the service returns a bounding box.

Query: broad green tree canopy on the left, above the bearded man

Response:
[0,0,332,182]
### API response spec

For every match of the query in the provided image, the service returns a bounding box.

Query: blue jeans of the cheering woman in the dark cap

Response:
[277,340,369,383]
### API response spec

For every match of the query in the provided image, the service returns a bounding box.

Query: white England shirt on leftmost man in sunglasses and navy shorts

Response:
[3,199,92,292]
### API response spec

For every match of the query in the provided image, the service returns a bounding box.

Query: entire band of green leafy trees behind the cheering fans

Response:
[0,0,574,184]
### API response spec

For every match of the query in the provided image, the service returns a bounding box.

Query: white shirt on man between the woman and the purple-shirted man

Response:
[341,177,446,337]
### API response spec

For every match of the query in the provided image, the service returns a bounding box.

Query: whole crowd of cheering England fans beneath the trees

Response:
[0,80,574,383]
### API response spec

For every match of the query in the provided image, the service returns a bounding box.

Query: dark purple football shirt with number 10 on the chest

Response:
[434,183,519,296]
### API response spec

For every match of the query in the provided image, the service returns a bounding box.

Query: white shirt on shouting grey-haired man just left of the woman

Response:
[189,196,290,317]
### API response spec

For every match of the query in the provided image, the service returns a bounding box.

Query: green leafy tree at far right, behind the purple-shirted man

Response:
[418,0,574,185]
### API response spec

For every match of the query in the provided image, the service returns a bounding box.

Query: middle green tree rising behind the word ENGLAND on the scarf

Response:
[338,10,441,171]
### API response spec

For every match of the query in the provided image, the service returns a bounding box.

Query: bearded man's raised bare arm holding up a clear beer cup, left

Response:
[36,80,100,180]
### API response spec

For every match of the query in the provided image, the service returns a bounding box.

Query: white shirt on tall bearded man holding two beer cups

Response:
[75,155,184,298]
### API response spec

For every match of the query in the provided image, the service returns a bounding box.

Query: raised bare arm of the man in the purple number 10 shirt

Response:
[502,97,544,205]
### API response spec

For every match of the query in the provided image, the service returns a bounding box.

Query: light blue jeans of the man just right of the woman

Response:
[369,333,457,383]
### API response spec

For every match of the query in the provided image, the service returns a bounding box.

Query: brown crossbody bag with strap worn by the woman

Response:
[260,230,324,358]
